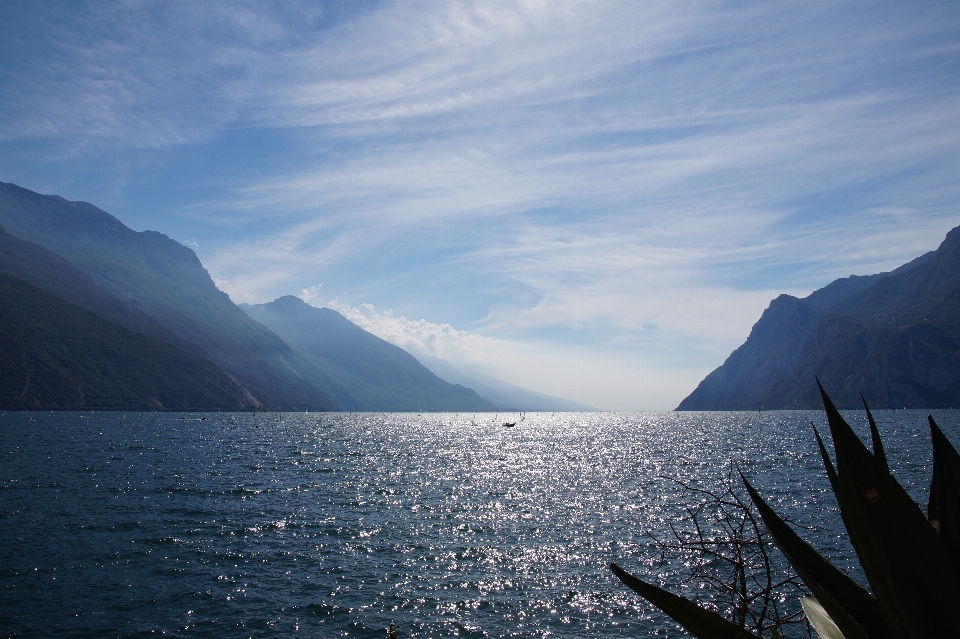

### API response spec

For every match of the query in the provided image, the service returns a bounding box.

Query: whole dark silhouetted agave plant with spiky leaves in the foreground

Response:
[610,380,960,639]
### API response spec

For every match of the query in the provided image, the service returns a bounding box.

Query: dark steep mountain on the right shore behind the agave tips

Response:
[677,227,960,410]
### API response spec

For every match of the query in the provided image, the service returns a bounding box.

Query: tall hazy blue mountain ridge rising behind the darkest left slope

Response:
[0,183,344,410]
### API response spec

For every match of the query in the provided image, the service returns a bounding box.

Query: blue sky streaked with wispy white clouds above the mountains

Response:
[0,0,960,410]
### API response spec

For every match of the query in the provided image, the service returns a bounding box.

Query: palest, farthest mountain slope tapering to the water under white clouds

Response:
[419,356,599,413]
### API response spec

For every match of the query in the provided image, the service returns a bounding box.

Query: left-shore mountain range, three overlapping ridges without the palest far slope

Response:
[0,182,560,412]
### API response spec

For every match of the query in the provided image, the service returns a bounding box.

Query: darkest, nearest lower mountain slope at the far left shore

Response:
[0,274,258,410]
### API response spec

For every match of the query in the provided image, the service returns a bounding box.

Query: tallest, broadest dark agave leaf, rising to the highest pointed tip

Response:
[817,380,960,639]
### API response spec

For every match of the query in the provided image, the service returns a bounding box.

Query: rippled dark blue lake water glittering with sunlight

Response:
[0,411,960,638]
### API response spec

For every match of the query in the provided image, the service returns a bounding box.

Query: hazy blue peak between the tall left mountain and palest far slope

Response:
[240,295,494,412]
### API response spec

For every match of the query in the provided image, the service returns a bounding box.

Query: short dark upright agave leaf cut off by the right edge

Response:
[927,416,960,574]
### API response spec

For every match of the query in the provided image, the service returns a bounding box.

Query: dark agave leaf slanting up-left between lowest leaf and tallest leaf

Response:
[740,474,892,639]
